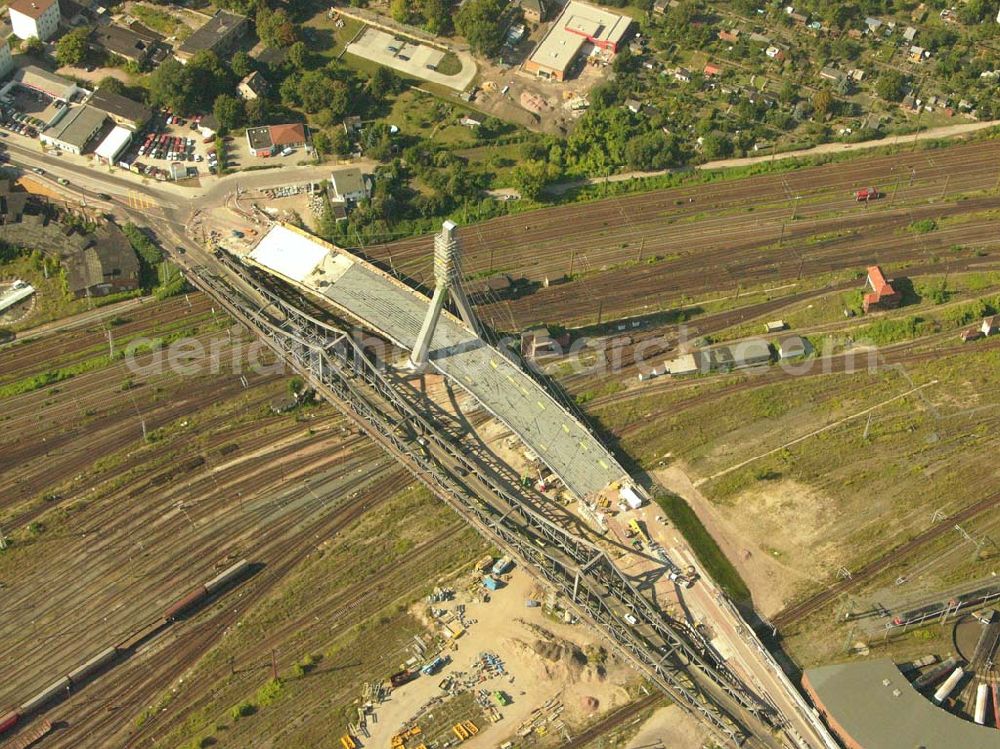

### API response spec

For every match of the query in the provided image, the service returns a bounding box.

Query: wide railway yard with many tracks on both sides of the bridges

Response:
[0,127,1000,749]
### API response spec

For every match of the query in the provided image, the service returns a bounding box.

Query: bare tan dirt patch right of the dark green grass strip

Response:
[653,465,810,616]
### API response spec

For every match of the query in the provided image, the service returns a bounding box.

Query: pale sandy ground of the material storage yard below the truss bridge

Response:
[364,568,636,749]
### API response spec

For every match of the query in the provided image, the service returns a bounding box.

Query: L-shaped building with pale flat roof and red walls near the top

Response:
[524,0,632,81]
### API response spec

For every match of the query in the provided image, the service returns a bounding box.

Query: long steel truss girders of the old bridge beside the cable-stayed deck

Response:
[199,263,781,744]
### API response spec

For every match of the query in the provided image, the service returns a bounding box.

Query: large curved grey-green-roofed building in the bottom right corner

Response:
[802,659,1000,749]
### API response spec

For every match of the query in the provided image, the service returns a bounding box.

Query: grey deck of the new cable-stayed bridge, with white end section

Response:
[248,225,627,497]
